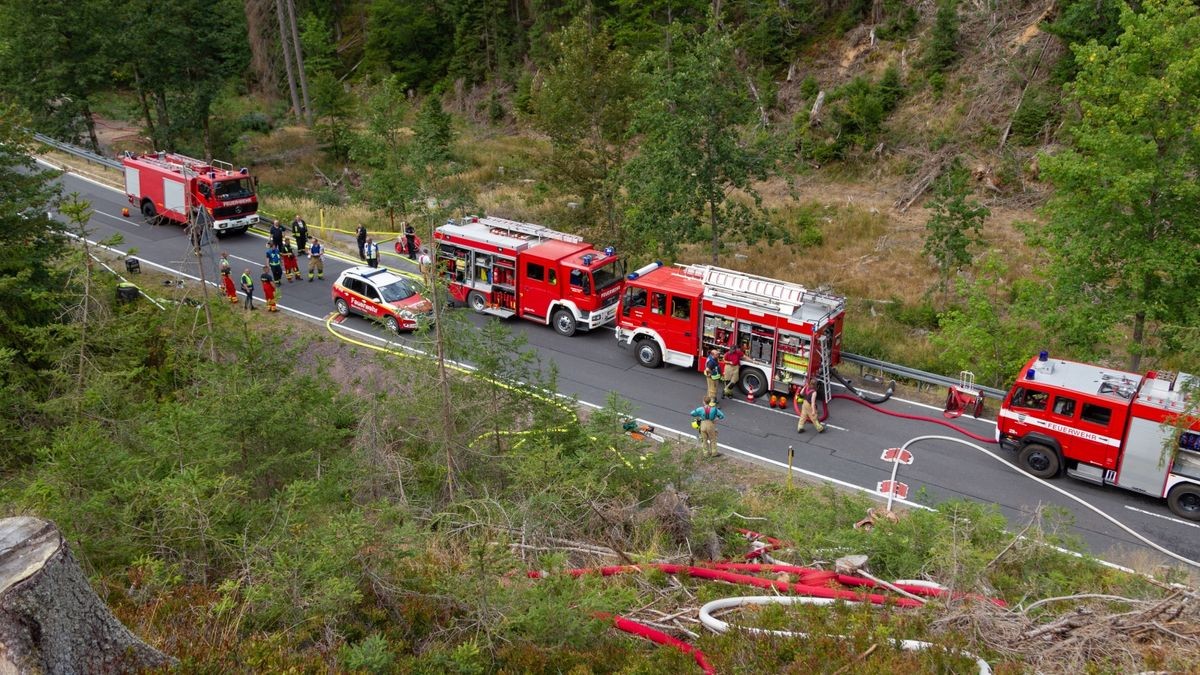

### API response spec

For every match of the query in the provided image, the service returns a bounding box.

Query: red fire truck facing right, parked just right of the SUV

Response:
[433,216,625,338]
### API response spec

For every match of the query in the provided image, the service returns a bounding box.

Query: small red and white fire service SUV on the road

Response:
[332,267,433,331]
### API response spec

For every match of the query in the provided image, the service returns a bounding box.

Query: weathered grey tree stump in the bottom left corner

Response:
[0,516,178,675]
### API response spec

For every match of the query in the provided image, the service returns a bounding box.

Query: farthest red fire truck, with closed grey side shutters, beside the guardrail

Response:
[121,153,258,234]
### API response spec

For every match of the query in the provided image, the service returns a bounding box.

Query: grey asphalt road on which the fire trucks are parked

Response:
[51,163,1200,562]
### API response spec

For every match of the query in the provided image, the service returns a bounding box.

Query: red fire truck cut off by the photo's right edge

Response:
[996,352,1200,520]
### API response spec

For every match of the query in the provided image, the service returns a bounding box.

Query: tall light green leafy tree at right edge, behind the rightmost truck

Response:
[1033,0,1200,370]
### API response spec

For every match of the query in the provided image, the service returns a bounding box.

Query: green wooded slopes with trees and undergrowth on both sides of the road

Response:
[0,0,1200,673]
